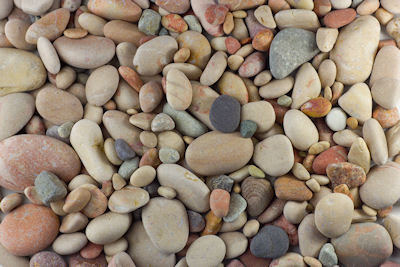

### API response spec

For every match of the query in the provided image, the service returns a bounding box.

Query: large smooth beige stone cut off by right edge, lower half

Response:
[360,162,400,209]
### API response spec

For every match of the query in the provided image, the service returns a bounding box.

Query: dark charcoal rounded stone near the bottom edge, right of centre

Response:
[250,225,289,258]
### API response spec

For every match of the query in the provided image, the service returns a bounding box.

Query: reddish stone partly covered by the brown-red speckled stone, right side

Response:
[312,146,347,174]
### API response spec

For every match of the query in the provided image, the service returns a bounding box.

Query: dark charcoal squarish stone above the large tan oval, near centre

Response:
[210,95,240,133]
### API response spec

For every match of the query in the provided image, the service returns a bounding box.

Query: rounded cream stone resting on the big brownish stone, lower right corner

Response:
[315,193,354,238]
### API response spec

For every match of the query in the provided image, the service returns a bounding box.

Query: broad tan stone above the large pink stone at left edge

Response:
[36,87,83,125]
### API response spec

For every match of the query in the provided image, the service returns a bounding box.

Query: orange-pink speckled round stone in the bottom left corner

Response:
[0,204,60,256]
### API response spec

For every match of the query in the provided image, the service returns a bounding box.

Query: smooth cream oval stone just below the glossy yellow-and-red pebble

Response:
[283,109,319,151]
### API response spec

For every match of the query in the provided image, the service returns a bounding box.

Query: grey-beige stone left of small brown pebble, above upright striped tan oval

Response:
[133,36,178,76]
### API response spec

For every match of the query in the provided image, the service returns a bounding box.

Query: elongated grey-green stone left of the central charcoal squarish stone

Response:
[163,103,207,138]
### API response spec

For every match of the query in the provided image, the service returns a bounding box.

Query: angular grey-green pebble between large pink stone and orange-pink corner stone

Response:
[35,171,67,204]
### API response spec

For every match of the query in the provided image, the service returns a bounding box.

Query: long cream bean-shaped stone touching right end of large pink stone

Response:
[70,119,114,182]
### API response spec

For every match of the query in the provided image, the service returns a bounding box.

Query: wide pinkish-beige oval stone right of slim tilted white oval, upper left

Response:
[54,35,115,69]
